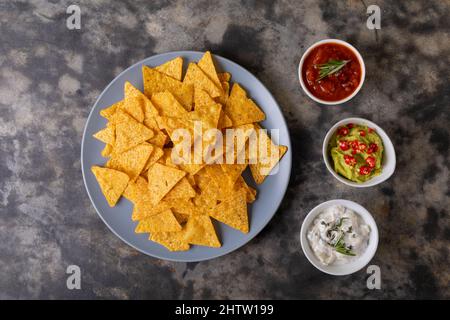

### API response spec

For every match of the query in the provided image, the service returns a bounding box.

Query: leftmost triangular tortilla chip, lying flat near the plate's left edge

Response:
[91,166,129,207]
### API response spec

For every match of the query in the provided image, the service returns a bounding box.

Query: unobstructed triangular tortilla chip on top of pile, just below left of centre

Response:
[148,163,186,205]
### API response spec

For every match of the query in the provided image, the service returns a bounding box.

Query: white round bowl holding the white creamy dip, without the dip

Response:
[300,199,378,276]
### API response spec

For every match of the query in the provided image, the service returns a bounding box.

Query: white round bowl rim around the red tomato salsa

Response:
[298,39,366,105]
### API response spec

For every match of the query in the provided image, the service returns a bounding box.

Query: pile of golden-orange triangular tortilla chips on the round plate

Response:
[92,52,287,251]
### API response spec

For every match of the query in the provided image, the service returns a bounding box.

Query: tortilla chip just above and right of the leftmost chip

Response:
[106,143,153,181]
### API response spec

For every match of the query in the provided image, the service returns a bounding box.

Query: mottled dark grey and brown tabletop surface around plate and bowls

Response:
[0,0,450,299]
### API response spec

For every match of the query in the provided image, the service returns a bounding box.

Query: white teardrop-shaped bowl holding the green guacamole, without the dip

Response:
[322,118,396,188]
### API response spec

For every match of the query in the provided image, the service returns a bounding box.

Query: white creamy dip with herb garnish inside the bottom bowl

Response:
[308,205,370,265]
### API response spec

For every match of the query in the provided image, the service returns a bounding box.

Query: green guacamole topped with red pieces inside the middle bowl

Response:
[328,123,384,183]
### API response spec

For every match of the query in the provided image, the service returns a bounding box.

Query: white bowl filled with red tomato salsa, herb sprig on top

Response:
[299,39,365,105]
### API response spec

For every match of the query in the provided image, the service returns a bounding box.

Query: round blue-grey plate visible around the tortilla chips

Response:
[81,51,292,262]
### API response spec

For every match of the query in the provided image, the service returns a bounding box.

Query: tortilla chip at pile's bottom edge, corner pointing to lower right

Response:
[185,215,221,248]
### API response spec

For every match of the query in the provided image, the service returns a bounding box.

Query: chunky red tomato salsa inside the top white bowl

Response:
[302,42,361,101]
